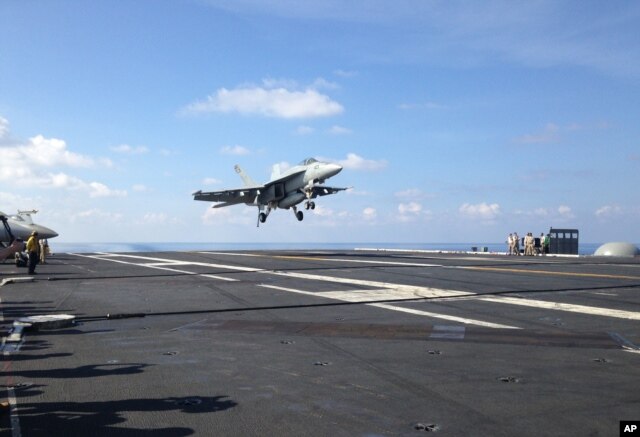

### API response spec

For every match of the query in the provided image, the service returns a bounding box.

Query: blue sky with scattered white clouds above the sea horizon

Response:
[0,0,640,242]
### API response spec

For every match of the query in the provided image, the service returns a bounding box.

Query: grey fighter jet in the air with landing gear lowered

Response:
[193,158,347,226]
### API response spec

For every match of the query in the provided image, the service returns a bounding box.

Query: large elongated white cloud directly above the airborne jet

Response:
[182,83,344,119]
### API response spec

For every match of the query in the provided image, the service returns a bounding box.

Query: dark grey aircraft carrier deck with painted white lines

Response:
[0,251,640,437]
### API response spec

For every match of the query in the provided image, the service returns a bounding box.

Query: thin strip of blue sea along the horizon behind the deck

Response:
[49,240,601,255]
